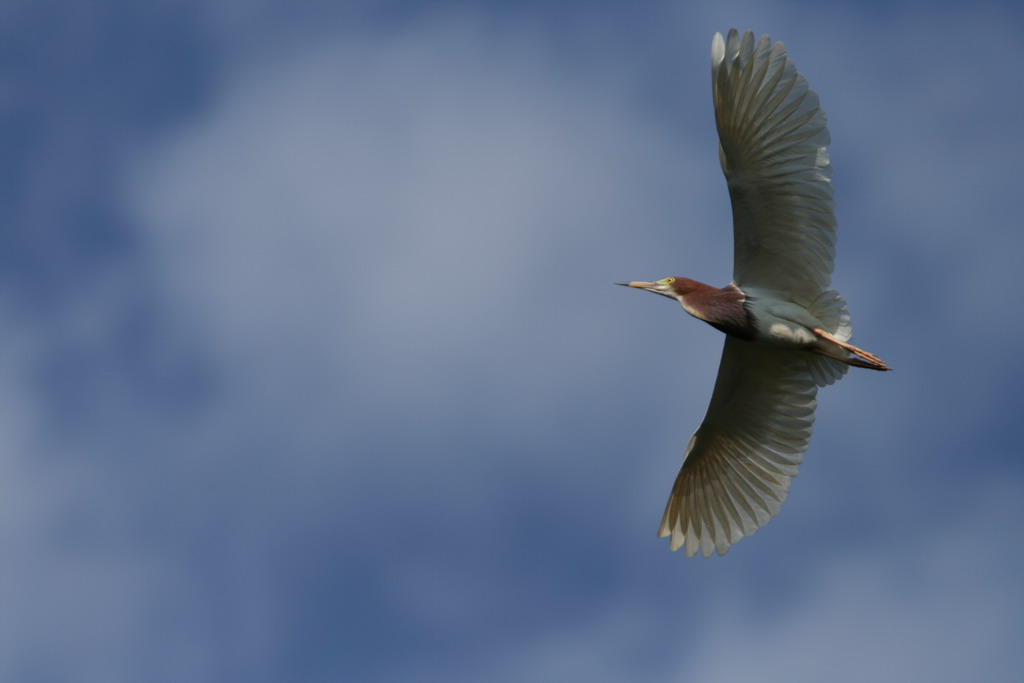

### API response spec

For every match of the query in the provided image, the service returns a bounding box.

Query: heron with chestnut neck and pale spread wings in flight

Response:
[615,29,890,557]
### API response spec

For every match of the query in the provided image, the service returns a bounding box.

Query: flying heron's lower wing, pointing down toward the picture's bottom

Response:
[658,337,817,557]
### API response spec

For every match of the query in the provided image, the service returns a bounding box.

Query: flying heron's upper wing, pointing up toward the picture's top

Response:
[711,29,836,305]
